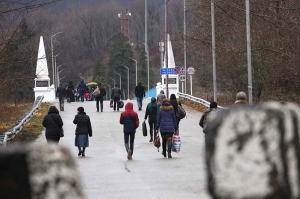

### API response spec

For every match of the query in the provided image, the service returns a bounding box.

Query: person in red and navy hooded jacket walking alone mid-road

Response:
[120,102,140,160]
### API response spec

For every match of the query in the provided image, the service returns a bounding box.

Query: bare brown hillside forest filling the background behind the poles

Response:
[0,0,300,105]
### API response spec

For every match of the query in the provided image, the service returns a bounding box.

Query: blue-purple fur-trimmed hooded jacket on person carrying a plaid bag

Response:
[156,102,178,134]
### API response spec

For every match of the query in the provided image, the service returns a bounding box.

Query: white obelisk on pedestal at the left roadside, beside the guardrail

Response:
[33,36,55,102]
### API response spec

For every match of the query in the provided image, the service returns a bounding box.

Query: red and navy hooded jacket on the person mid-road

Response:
[120,102,140,133]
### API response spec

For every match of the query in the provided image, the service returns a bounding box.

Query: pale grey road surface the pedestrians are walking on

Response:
[37,100,210,199]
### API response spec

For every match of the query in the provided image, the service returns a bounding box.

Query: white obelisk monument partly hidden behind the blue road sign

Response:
[156,35,179,98]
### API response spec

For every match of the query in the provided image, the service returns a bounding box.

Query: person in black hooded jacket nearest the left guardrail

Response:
[42,106,64,144]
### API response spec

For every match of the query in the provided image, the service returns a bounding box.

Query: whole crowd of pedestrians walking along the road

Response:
[50,80,249,160]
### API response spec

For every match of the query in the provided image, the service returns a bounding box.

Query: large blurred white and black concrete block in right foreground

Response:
[206,102,300,199]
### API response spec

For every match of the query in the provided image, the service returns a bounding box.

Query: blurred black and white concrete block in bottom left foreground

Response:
[0,144,85,199]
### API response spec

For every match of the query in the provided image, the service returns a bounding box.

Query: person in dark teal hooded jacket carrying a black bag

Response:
[144,97,159,142]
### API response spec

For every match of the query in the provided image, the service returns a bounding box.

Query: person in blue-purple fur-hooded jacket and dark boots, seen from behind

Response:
[156,99,179,158]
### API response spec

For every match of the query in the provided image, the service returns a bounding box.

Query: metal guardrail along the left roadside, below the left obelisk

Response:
[0,96,44,146]
